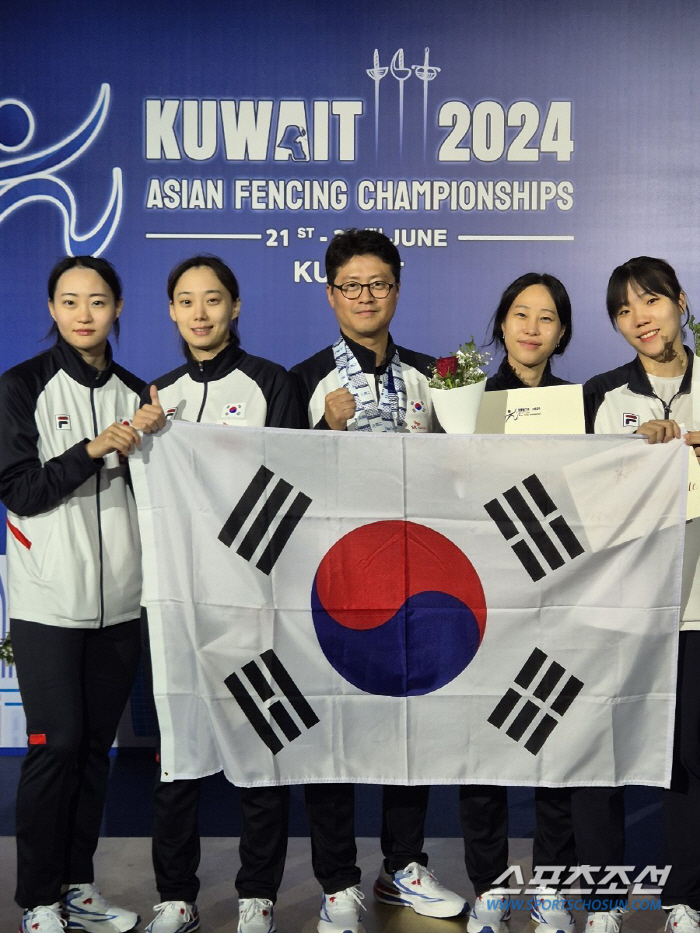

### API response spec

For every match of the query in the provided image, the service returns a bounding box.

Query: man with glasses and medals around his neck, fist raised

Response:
[291,229,466,933]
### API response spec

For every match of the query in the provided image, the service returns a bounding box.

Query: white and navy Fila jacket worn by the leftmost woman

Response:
[0,339,143,628]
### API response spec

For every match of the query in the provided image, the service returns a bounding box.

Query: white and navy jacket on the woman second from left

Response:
[148,339,299,428]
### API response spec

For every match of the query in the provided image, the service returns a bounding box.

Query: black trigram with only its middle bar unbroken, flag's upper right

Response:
[484,473,583,583]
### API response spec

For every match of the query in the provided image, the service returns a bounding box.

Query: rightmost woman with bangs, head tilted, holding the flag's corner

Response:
[584,256,700,933]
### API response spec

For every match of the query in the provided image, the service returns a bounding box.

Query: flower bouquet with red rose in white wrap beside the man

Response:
[428,337,491,434]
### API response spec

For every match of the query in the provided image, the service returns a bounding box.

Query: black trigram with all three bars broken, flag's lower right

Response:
[488,648,583,755]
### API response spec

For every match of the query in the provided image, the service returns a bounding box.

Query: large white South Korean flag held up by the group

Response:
[132,422,687,785]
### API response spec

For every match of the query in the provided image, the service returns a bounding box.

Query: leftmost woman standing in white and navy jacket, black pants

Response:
[0,256,164,933]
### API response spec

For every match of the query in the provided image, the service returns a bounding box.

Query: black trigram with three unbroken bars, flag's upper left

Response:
[219,466,311,574]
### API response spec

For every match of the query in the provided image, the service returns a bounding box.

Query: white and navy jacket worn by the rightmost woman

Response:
[583,347,700,631]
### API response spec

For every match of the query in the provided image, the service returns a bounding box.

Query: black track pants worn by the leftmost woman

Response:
[10,619,141,909]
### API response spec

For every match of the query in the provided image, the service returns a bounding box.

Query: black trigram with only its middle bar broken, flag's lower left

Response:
[224,650,319,755]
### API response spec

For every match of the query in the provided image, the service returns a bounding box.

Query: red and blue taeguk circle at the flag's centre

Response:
[311,521,486,697]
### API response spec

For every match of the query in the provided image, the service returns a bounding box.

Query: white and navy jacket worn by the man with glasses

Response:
[289,334,440,434]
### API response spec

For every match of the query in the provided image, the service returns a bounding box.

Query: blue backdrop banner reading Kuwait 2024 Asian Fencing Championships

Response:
[0,0,700,744]
